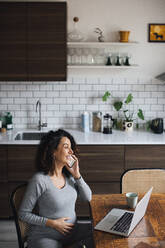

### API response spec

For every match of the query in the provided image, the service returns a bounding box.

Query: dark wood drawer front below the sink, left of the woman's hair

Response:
[8,145,37,182]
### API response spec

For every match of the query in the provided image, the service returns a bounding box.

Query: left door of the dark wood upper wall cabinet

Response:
[0,2,27,81]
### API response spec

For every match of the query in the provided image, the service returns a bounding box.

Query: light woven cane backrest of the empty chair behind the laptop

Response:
[120,168,165,193]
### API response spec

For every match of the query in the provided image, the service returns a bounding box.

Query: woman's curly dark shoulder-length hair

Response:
[36,129,78,176]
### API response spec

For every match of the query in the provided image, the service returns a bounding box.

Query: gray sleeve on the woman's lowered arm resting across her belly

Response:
[19,175,47,226]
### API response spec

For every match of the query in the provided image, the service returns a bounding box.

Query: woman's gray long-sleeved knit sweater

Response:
[19,173,92,226]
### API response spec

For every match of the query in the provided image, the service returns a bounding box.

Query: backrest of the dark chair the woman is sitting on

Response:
[10,184,30,248]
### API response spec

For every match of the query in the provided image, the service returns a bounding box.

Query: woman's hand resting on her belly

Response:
[46,217,74,235]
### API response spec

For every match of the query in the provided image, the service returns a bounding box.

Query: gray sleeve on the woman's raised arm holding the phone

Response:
[75,177,92,201]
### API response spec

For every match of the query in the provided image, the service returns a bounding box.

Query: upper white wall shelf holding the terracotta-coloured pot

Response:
[67,41,139,47]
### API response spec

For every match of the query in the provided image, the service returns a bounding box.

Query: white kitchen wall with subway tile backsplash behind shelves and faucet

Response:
[0,0,165,128]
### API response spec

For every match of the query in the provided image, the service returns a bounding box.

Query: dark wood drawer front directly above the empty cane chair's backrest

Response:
[125,145,165,169]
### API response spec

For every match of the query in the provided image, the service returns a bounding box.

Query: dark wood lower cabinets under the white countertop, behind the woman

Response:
[0,145,165,218]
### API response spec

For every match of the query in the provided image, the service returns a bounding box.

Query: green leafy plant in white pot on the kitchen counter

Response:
[102,91,144,130]
